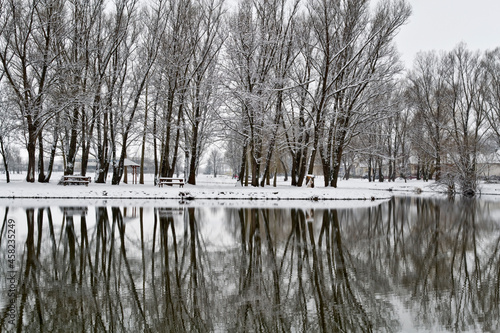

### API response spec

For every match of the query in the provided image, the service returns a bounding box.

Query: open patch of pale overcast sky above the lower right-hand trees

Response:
[396,0,500,67]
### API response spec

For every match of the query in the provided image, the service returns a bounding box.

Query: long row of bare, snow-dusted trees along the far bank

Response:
[0,0,500,195]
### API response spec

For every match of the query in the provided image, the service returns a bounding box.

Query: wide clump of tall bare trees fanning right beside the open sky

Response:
[284,1,411,187]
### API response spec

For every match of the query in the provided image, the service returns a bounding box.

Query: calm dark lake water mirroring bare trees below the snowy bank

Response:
[0,197,500,332]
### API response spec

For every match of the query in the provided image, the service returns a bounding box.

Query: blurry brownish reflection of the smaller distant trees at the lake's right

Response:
[344,197,500,331]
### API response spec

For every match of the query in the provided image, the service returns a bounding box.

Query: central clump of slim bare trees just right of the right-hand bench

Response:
[226,0,298,186]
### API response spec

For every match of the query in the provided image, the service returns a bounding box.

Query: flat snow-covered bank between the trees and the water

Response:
[0,174,500,206]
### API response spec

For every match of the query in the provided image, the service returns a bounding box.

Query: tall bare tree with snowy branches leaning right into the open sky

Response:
[309,1,411,187]
